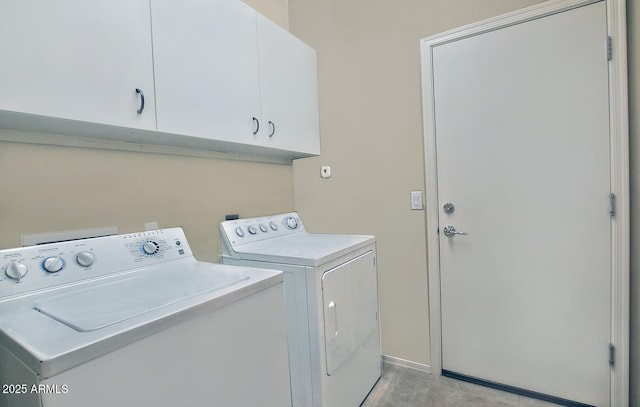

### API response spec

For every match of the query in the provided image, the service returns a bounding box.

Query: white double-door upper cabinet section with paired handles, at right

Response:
[151,0,320,158]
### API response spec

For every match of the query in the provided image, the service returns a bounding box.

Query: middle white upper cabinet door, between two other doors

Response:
[151,0,262,144]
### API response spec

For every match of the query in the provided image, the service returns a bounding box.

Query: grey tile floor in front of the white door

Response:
[361,363,557,407]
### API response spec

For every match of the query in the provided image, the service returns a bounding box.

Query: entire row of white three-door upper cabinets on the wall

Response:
[0,0,320,160]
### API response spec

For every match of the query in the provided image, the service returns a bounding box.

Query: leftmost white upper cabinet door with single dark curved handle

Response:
[0,0,155,130]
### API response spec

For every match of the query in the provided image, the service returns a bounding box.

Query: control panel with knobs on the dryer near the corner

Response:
[220,212,305,245]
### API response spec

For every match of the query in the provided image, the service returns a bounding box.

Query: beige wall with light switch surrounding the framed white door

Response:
[289,6,640,406]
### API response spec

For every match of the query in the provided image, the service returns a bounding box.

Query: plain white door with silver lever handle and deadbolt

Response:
[432,2,611,406]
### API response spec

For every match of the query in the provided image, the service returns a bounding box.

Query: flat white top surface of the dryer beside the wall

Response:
[223,232,375,267]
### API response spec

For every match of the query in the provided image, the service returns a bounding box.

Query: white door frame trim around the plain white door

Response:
[420,0,630,406]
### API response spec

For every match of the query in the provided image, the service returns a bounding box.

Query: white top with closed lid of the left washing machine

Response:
[0,256,282,379]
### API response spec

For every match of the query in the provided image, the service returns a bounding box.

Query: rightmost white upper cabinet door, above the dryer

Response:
[258,15,320,154]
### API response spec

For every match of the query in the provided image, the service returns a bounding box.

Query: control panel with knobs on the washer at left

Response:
[0,228,193,301]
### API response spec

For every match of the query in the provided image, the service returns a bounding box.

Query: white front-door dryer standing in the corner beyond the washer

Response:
[220,212,382,407]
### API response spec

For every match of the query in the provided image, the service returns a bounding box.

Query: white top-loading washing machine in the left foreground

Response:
[0,228,291,407]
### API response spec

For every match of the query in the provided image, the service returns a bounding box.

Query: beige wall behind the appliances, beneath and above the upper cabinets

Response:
[0,0,293,261]
